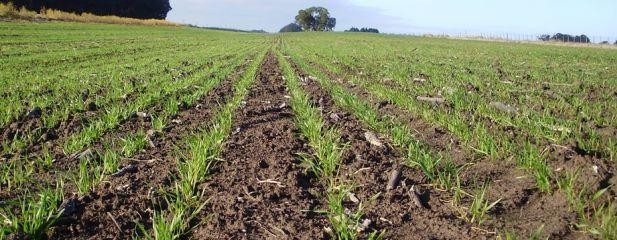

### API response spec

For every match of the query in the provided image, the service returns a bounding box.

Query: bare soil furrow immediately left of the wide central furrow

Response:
[51,60,244,239]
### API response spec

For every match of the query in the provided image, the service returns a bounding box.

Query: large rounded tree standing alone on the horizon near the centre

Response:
[296,7,336,31]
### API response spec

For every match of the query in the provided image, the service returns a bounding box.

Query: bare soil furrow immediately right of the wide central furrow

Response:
[291,57,482,239]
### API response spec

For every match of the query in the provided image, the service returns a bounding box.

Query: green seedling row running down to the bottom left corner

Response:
[4,47,268,237]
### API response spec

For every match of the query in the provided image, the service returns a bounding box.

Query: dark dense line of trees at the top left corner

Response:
[0,0,171,19]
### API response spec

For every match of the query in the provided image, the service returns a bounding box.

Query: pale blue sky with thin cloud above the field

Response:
[167,0,617,39]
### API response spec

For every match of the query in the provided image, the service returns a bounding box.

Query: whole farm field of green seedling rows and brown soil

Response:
[0,22,617,239]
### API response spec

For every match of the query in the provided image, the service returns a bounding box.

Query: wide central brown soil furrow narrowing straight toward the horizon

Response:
[192,53,326,239]
